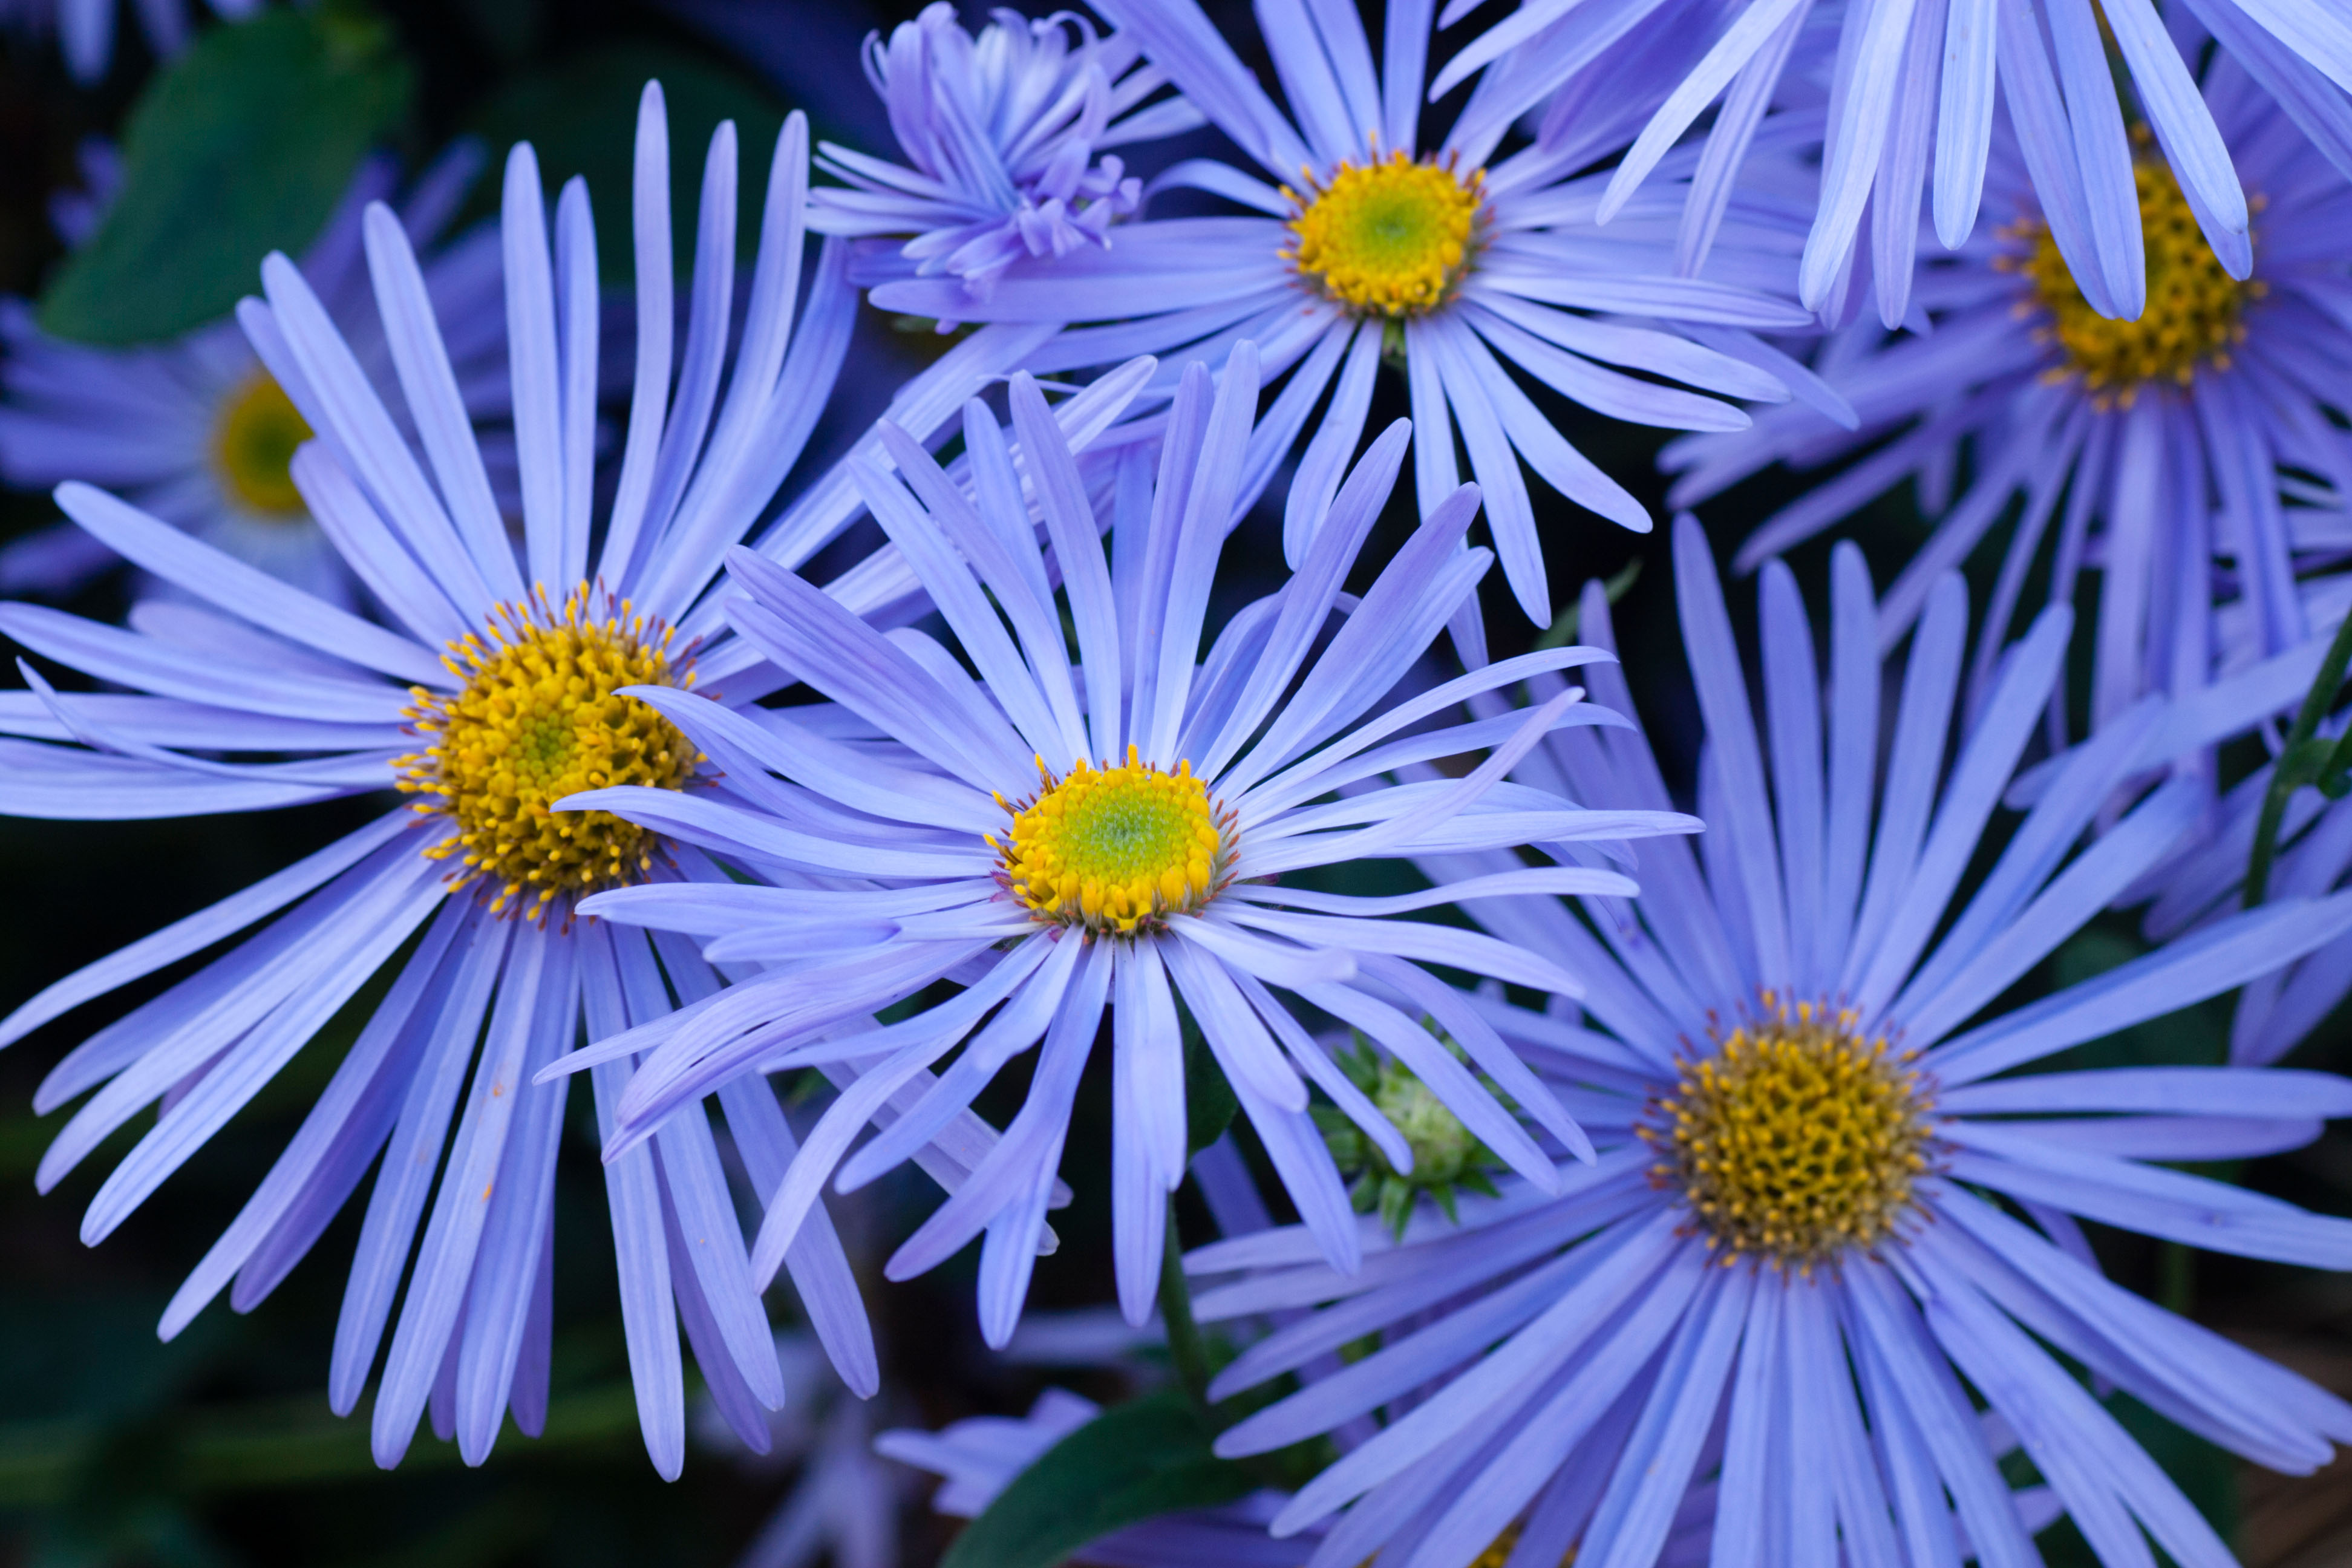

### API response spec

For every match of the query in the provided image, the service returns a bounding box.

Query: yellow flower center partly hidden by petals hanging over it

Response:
[2004,153,2265,409]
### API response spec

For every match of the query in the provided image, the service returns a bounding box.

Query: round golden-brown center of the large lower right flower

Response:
[1642,992,1931,1272]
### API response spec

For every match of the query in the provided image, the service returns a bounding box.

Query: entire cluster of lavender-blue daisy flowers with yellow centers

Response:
[13,0,2352,1568]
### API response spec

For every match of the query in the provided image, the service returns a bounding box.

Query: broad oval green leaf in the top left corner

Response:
[40,5,411,343]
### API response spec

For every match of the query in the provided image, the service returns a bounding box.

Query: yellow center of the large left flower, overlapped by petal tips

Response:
[395,586,701,919]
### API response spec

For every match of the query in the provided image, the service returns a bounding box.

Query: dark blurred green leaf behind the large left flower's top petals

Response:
[468,42,814,287]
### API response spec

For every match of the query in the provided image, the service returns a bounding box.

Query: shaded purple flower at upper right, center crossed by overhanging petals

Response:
[1663,56,2352,747]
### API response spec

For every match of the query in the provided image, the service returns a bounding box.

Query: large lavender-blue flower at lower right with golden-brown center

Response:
[1187,522,2352,1568]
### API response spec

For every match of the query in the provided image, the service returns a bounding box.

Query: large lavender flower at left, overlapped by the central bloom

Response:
[0,87,912,1474]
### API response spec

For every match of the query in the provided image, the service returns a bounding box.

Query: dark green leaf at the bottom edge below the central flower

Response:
[938,1390,1258,1568]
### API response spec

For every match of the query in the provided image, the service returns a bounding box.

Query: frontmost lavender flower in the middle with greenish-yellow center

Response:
[562,345,1696,1345]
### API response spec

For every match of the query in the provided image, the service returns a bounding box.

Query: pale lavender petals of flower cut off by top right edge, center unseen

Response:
[1439,0,2352,327]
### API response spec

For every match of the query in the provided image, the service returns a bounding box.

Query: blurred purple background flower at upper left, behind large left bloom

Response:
[0,146,513,607]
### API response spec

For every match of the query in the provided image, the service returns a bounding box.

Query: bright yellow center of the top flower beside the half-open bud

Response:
[1282,153,1484,318]
